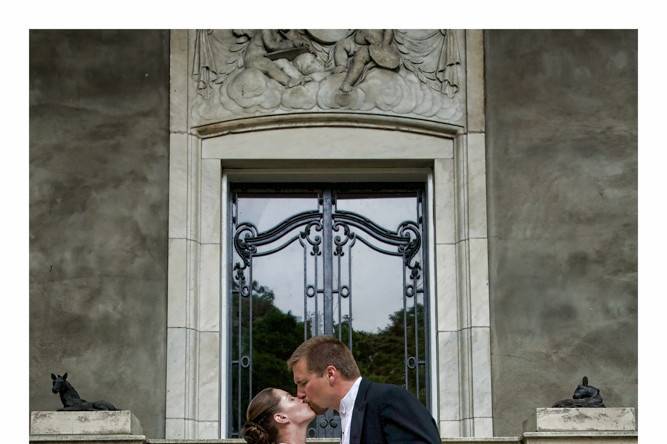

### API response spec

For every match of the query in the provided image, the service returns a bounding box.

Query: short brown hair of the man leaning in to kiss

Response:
[287,336,361,380]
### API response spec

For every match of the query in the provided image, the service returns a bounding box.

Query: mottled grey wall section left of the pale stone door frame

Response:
[30,31,169,437]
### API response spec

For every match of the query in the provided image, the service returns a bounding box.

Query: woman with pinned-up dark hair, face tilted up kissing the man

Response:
[241,387,315,444]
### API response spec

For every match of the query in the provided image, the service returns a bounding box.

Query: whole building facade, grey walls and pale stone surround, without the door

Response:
[30,30,637,438]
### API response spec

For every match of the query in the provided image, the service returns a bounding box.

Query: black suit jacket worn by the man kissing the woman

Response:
[350,378,441,444]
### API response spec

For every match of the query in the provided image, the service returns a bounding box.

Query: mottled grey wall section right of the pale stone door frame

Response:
[485,31,637,435]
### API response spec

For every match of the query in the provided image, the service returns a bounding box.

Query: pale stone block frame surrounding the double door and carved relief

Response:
[165,30,493,439]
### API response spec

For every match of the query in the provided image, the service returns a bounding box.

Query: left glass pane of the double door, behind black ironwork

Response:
[231,193,321,436]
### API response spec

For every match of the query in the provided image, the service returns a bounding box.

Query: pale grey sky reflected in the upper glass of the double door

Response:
[234,191,417,334]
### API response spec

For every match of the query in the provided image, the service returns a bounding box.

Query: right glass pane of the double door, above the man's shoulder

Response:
[336,193,425,394]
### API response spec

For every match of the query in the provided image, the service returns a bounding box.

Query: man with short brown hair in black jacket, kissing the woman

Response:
[287,336,441,444]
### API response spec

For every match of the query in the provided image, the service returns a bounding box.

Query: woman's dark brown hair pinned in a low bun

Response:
[241,387,280,444]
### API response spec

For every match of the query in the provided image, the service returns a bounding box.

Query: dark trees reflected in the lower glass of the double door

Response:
[231,281,426,436]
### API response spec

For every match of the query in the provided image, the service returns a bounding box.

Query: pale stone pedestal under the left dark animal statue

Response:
[30,410,146,444]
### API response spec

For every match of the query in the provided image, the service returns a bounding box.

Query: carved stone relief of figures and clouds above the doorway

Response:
[191,29,465,125]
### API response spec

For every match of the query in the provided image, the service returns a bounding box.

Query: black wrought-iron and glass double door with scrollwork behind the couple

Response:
[227,183,431,437]
